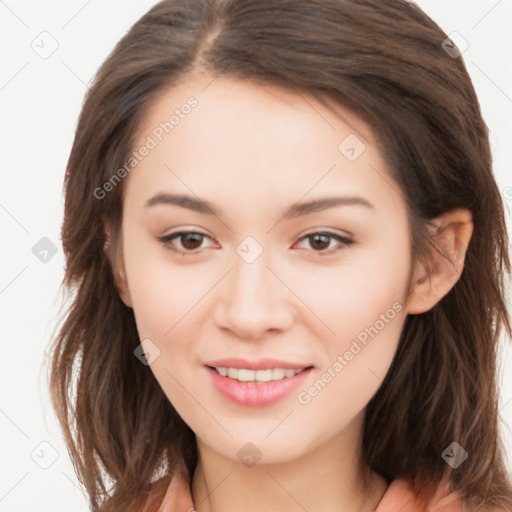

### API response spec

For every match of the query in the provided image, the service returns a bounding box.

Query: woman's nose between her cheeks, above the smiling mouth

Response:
[214,248,294,340]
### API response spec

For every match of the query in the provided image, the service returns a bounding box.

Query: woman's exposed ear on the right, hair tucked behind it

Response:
[406,208,473,314]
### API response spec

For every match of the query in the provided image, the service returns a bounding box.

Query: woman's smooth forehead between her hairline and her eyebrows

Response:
[126,71,404,220]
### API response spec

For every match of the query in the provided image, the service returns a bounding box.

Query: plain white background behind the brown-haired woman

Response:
[0,0,512,512]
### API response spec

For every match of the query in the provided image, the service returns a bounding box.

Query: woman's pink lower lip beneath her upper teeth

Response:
[206,367,312,407]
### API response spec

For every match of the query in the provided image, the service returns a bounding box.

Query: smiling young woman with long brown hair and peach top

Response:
[50,0,512,512]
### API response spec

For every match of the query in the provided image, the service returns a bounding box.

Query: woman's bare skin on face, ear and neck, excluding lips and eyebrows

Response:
[111,70,472,512]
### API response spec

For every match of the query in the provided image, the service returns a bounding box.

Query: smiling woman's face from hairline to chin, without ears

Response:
[115,71,411,463]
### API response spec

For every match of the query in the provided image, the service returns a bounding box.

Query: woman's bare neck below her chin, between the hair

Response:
[192,414,387,512]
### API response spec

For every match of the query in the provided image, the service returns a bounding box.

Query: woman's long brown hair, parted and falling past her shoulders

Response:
[49,0,512,511]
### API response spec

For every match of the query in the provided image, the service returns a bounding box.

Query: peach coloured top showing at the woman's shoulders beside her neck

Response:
[146,475,462,512]
